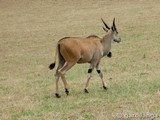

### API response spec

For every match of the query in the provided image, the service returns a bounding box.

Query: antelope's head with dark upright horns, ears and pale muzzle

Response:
[101,18,121,43]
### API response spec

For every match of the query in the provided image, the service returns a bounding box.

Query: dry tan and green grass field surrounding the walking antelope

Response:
[0,0,160,120]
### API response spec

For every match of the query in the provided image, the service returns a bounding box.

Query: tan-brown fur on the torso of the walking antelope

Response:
[58,37,103,64]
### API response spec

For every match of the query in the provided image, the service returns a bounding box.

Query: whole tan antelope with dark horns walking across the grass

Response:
[49,18,121,98]
